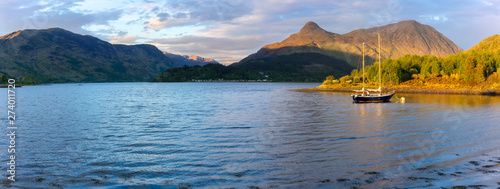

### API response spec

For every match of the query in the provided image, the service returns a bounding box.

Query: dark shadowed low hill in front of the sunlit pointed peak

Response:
[152,53,354,82]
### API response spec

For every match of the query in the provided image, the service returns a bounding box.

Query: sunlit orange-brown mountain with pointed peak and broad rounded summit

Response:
[239,20,463,67]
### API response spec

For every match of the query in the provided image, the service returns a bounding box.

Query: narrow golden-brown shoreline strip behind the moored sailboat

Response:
[292,86,500,96]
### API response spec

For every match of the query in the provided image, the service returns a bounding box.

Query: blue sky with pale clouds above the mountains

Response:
[0,0,500,64]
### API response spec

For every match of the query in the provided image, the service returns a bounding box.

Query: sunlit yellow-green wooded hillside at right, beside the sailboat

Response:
[322,35,500,89]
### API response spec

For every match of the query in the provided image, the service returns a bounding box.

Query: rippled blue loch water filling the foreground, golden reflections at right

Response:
[0,83,500,188]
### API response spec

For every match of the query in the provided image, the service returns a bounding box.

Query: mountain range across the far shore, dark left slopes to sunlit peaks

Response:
[0,20,463,82]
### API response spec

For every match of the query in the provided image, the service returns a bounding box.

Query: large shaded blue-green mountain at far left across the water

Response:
[0,28,180,82]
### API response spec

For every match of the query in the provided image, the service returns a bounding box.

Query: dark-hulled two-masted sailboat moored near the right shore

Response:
[352,34,395,102]
